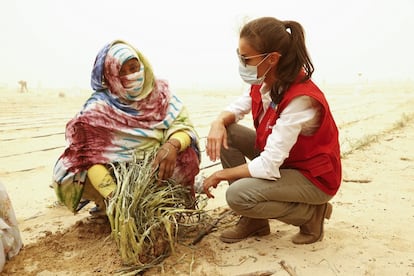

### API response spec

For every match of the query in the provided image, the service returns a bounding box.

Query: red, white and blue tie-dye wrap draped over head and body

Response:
[53,40,200,212]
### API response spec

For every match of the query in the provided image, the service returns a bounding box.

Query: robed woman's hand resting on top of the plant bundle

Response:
[153,143,178,182]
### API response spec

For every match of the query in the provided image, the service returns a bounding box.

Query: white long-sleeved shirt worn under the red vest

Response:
[225,86,321,180]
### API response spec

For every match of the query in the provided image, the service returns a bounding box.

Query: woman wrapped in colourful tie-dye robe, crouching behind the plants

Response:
[53,40,200,213]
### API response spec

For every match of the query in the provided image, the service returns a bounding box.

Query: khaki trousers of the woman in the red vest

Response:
[221,124,332,226]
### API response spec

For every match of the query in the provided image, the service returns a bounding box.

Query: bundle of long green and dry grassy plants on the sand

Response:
[107,151,204,273]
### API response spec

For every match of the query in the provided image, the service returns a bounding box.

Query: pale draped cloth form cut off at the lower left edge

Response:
[0,182,23,273]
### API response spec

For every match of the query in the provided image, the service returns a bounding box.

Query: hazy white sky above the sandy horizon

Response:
[0,0,414,89]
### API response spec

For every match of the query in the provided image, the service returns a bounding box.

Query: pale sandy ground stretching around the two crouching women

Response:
[0,83,414,275]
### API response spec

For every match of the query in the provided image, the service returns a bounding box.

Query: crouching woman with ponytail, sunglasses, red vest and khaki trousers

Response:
[203,17,341,244]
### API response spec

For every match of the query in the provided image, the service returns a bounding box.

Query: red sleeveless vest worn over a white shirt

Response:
[250,80,342,195]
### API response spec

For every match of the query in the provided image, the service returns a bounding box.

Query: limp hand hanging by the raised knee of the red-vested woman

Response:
[206,120,228,161]
